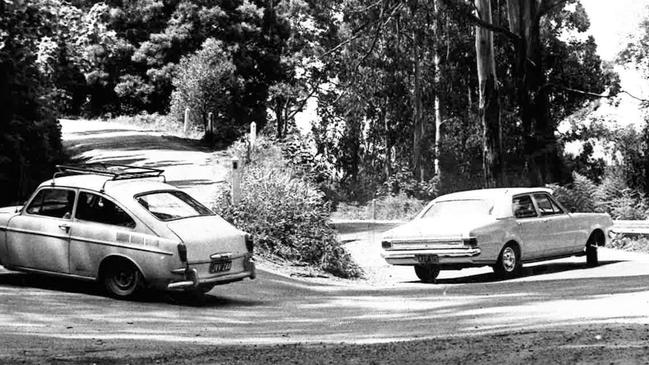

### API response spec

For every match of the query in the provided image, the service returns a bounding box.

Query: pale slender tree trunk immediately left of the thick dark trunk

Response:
[475,0,503,187]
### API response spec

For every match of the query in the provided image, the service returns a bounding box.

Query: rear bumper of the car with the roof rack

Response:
[167,254,257,290]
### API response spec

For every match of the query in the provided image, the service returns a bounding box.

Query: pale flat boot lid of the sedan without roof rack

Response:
[383,216,496,240]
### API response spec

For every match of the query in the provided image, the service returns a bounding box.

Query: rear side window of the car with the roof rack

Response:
[76,191,135,228]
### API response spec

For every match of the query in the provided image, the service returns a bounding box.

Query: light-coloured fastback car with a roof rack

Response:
[0,164,255,297]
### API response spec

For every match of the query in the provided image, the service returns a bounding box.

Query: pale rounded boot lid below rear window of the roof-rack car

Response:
[167,215,247,262]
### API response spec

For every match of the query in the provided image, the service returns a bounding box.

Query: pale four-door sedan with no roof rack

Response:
[381,188,613,282]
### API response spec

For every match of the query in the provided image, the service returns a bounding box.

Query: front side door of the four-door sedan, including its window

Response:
[533,193,577,257]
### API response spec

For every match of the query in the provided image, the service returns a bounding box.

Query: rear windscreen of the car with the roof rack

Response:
[135,191,214,222]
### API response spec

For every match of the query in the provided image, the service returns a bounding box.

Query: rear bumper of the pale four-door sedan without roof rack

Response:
[381,247,481,265]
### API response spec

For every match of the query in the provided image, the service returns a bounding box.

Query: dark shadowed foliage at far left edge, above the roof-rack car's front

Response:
[0,1,63,203]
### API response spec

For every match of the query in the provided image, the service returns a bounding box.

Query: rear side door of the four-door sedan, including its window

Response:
[512,194,548,260]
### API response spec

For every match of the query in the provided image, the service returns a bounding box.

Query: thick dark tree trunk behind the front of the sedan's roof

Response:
[507,0,562,186]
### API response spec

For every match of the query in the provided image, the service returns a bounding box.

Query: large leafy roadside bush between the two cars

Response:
[215,140,362,278]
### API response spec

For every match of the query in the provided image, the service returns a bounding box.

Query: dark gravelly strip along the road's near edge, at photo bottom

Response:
[0,325,649,365]
